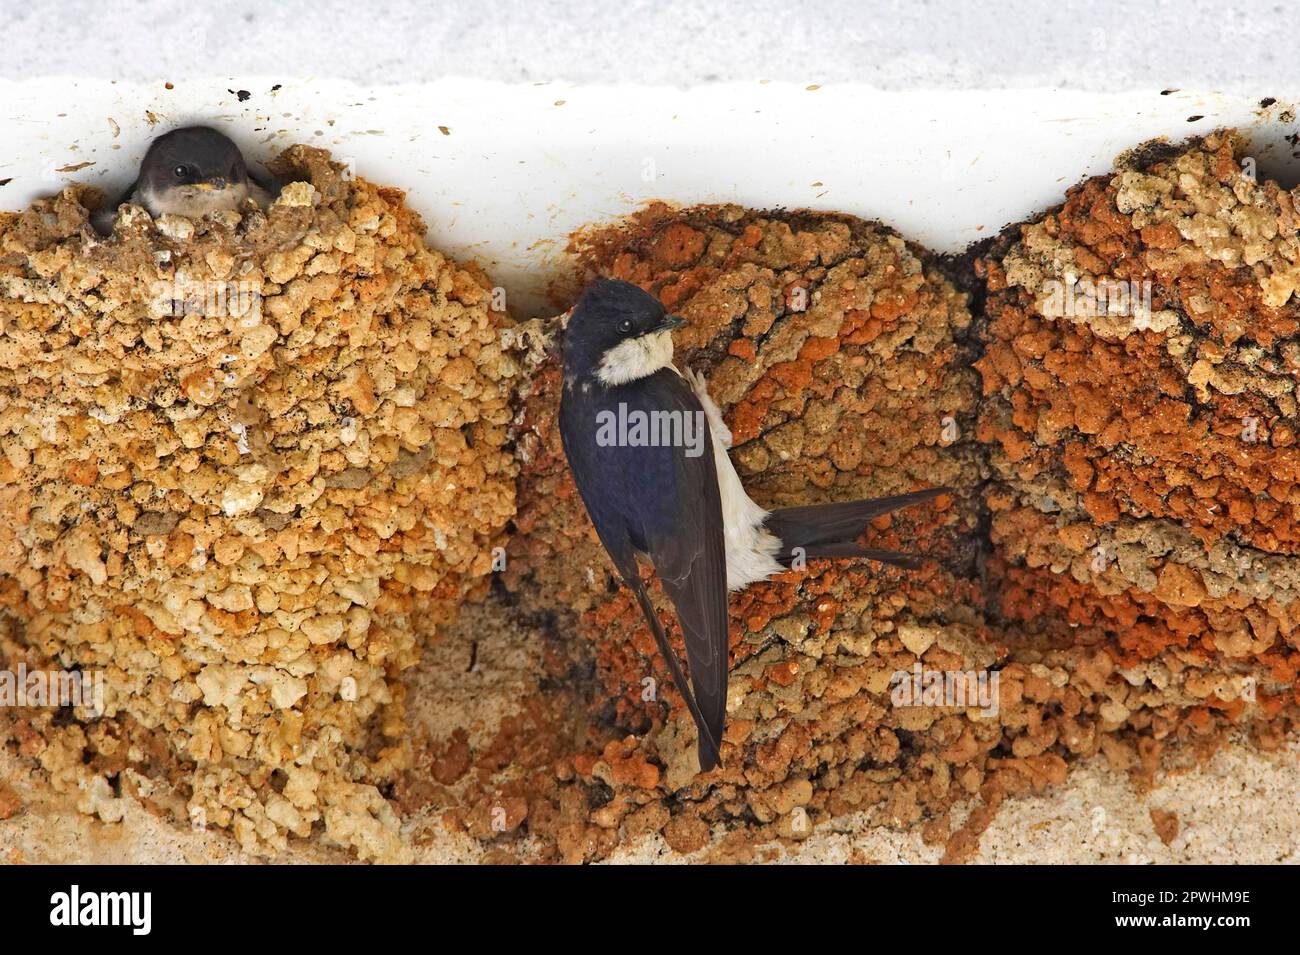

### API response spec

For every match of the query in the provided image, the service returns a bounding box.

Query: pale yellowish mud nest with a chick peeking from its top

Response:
[0,147,515,860]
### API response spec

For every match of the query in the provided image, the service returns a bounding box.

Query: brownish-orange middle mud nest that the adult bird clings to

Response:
[507,207,997,859]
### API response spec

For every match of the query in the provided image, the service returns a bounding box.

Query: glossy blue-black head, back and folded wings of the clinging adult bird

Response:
[560,282,727,770]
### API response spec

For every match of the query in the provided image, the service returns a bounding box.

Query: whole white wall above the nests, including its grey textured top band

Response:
[0,0,1300,314]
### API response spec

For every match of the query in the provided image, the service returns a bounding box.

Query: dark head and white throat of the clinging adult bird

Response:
[564,278,685,387]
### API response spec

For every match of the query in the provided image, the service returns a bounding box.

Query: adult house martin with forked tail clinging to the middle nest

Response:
[560,279,948,772]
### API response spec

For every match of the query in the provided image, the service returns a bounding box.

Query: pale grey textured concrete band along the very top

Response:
[0,0,1300,92]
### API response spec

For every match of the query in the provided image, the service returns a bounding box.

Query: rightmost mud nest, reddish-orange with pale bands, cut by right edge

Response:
[978,133,1300,784]
